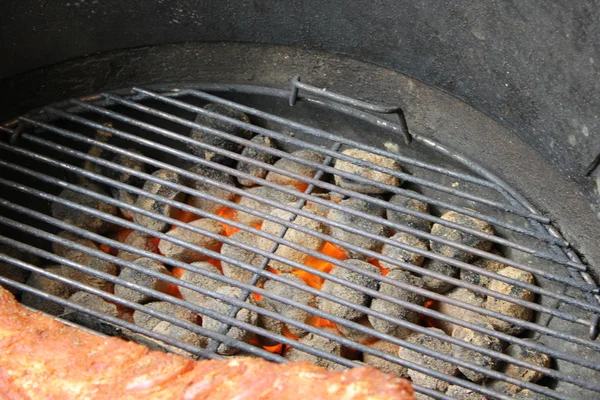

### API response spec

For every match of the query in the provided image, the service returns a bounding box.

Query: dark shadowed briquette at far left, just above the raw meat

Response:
[21,265,71,315]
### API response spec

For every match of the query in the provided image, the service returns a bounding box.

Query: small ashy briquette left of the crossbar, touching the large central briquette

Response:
[221,231,264,283]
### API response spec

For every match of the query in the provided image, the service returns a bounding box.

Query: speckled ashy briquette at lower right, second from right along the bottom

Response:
[452,320,502,382]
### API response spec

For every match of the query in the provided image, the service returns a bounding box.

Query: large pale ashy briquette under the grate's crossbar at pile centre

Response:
[257,210,325,272]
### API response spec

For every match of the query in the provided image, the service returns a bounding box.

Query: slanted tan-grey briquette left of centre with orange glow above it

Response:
[158,218,225,263]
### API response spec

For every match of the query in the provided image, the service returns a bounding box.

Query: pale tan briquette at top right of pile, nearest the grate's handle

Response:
[334,149,402,194]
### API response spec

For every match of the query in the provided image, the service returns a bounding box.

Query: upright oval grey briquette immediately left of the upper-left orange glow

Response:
[133,169,186,232]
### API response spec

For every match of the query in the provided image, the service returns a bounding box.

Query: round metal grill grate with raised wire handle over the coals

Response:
[0,79,600,399]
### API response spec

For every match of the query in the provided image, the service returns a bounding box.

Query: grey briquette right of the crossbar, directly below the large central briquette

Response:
[258,274,316,337]
